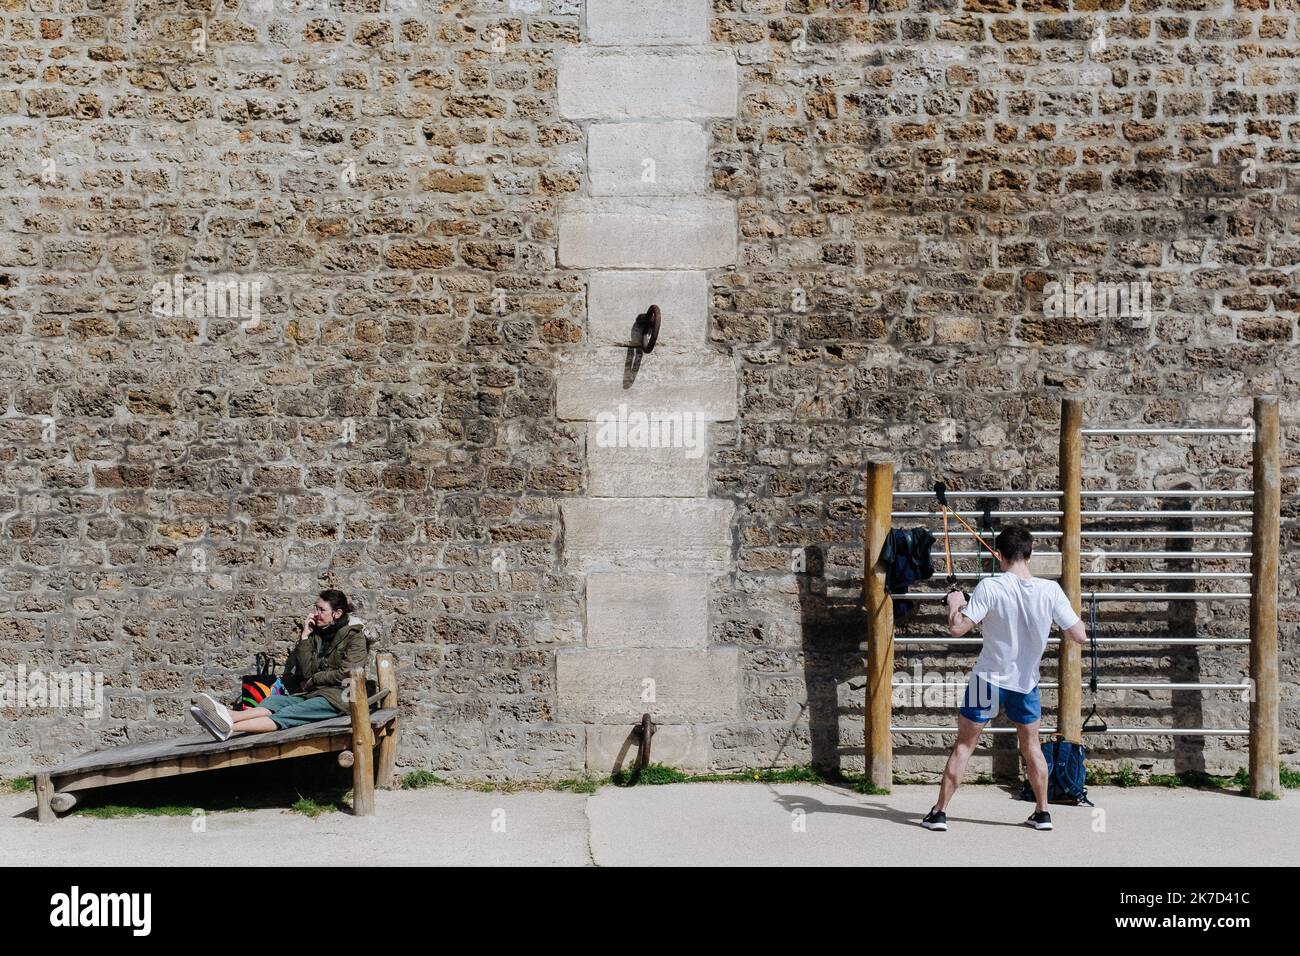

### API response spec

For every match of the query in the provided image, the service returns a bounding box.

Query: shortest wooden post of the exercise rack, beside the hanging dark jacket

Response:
[862,462,893,790]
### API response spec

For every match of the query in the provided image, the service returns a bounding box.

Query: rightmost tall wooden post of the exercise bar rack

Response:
[1251,397,1282,797]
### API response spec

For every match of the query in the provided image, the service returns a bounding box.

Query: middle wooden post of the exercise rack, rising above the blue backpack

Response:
[1057,398,1083,744]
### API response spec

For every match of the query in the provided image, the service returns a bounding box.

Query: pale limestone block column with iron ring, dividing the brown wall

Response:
[556,0,740,773]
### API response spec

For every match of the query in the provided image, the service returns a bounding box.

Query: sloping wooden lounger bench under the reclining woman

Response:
[33,654,398,823]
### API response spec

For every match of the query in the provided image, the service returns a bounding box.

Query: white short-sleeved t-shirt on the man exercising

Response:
[962,571,1079,693]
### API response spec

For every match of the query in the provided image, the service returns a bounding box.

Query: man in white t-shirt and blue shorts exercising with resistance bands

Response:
[920,525,1087,830]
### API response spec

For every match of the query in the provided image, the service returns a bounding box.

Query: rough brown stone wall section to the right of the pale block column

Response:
[711,0,1300,771]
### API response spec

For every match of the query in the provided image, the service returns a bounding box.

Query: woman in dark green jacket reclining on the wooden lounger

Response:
[190,591,368,740]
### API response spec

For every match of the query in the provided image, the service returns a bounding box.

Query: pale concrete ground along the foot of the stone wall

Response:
[0,783,1300,866]
